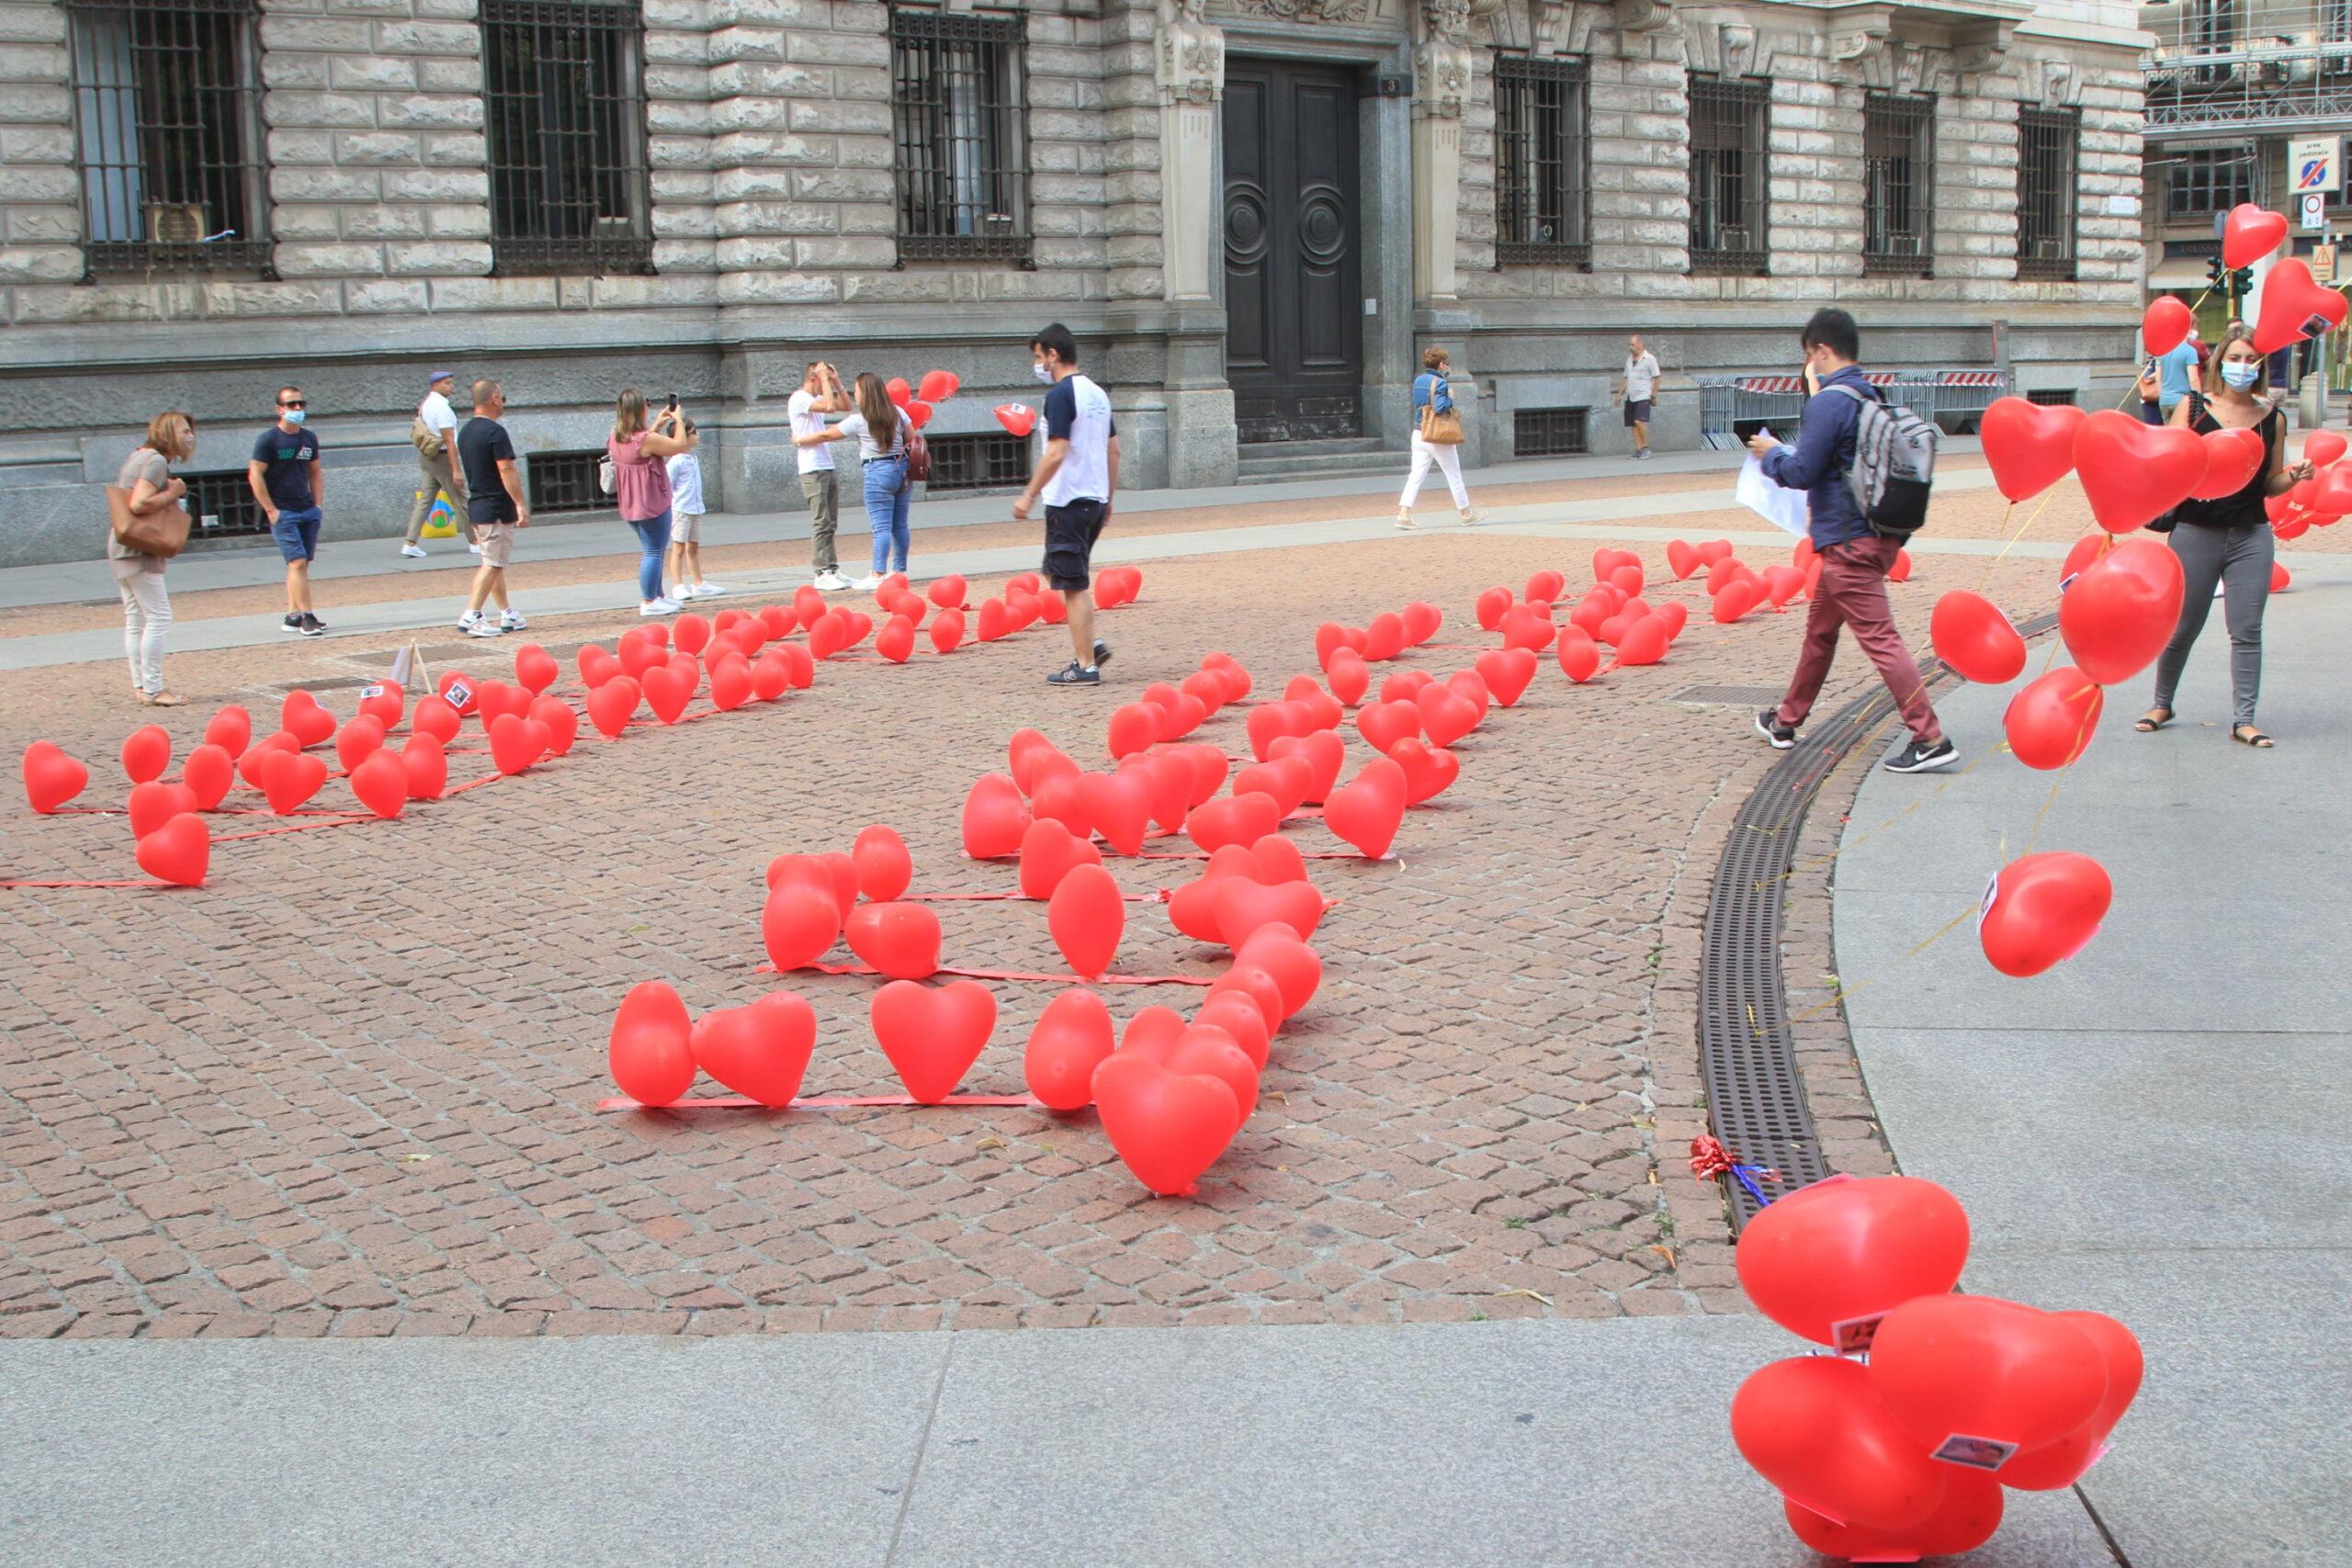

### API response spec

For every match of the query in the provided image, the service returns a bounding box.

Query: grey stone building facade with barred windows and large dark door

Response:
[0,0,2143,562]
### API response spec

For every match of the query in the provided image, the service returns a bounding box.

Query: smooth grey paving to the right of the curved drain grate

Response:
[1837,559,2352,1568]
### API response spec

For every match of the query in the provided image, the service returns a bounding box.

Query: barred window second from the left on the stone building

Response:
[482,0,654,275]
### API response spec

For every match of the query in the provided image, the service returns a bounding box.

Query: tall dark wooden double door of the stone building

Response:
[1223,59,1364,442]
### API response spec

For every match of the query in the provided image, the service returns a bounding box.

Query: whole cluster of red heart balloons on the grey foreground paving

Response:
[1731,1176,2141,1561]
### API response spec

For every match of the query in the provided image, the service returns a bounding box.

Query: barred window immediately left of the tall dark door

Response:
[889,7,1033,265]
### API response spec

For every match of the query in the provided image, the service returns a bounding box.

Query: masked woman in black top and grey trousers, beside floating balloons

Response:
[2133,327,2312,750]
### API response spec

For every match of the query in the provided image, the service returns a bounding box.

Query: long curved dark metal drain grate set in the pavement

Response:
[1675,616,2058,1229]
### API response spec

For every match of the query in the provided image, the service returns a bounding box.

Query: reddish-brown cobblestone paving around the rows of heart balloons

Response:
[0,479,2126,1336]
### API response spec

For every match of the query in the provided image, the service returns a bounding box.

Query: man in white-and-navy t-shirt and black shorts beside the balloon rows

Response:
[1013,322,1120,686]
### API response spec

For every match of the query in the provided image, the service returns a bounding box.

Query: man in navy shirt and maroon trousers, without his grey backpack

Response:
[1747,308,1959,773]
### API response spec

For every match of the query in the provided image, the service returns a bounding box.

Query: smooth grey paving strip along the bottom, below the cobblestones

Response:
[0,1316,2117,1568]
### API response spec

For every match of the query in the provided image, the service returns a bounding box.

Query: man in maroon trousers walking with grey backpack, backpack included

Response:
[1747,308,1959,773]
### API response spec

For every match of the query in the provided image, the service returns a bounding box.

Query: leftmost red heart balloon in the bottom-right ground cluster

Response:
[1731,1363,1957,1530]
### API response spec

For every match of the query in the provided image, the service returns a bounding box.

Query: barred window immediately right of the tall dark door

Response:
[1494,54,1592,268]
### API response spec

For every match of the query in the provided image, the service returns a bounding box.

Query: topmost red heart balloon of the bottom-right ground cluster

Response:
[1736,1176,1969,1354]
